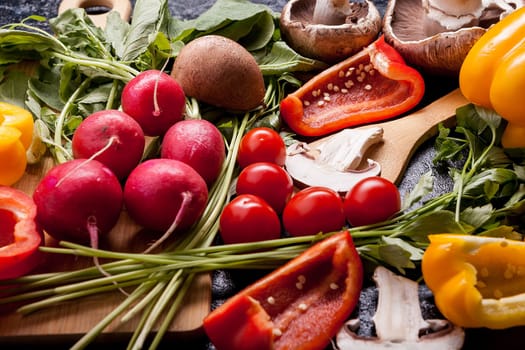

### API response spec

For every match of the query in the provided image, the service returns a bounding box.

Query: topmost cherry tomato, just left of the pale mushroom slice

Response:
[237,127,286,168]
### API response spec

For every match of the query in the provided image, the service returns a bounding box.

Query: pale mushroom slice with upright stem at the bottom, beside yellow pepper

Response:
[336,266,465,350]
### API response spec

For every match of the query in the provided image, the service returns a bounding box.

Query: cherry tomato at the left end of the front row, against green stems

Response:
[219,194,281,244]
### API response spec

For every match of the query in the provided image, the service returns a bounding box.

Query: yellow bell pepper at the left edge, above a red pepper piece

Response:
[0,102,33,186]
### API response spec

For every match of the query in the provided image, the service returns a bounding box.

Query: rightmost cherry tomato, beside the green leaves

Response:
[344,176,401,226]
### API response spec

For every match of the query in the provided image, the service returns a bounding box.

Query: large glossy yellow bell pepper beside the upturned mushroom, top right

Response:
[459,7,525,148]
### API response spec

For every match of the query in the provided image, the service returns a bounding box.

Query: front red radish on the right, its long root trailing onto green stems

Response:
[124,158,208,249]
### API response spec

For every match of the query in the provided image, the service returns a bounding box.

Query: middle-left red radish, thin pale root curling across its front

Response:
[72,110,146,179]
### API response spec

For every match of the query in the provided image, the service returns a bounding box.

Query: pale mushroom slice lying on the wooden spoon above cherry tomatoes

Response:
[285,127,383,193]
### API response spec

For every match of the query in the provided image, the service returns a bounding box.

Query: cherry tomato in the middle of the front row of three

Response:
[283,186,346,236]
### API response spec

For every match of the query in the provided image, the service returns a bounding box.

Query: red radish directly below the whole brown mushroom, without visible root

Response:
[161,119,226,186]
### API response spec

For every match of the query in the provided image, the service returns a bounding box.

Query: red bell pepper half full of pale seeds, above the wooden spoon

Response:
[280,36,425,136]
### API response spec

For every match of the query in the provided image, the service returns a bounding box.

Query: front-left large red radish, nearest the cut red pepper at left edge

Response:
[33,159,123,248]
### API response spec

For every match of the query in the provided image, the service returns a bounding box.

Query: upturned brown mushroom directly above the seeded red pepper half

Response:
[280,0,381,63]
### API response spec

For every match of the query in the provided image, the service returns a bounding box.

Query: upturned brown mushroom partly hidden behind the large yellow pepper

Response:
[383,0,523,77]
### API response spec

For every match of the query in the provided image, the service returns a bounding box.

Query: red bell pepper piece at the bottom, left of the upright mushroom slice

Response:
[204,231,363,350]
